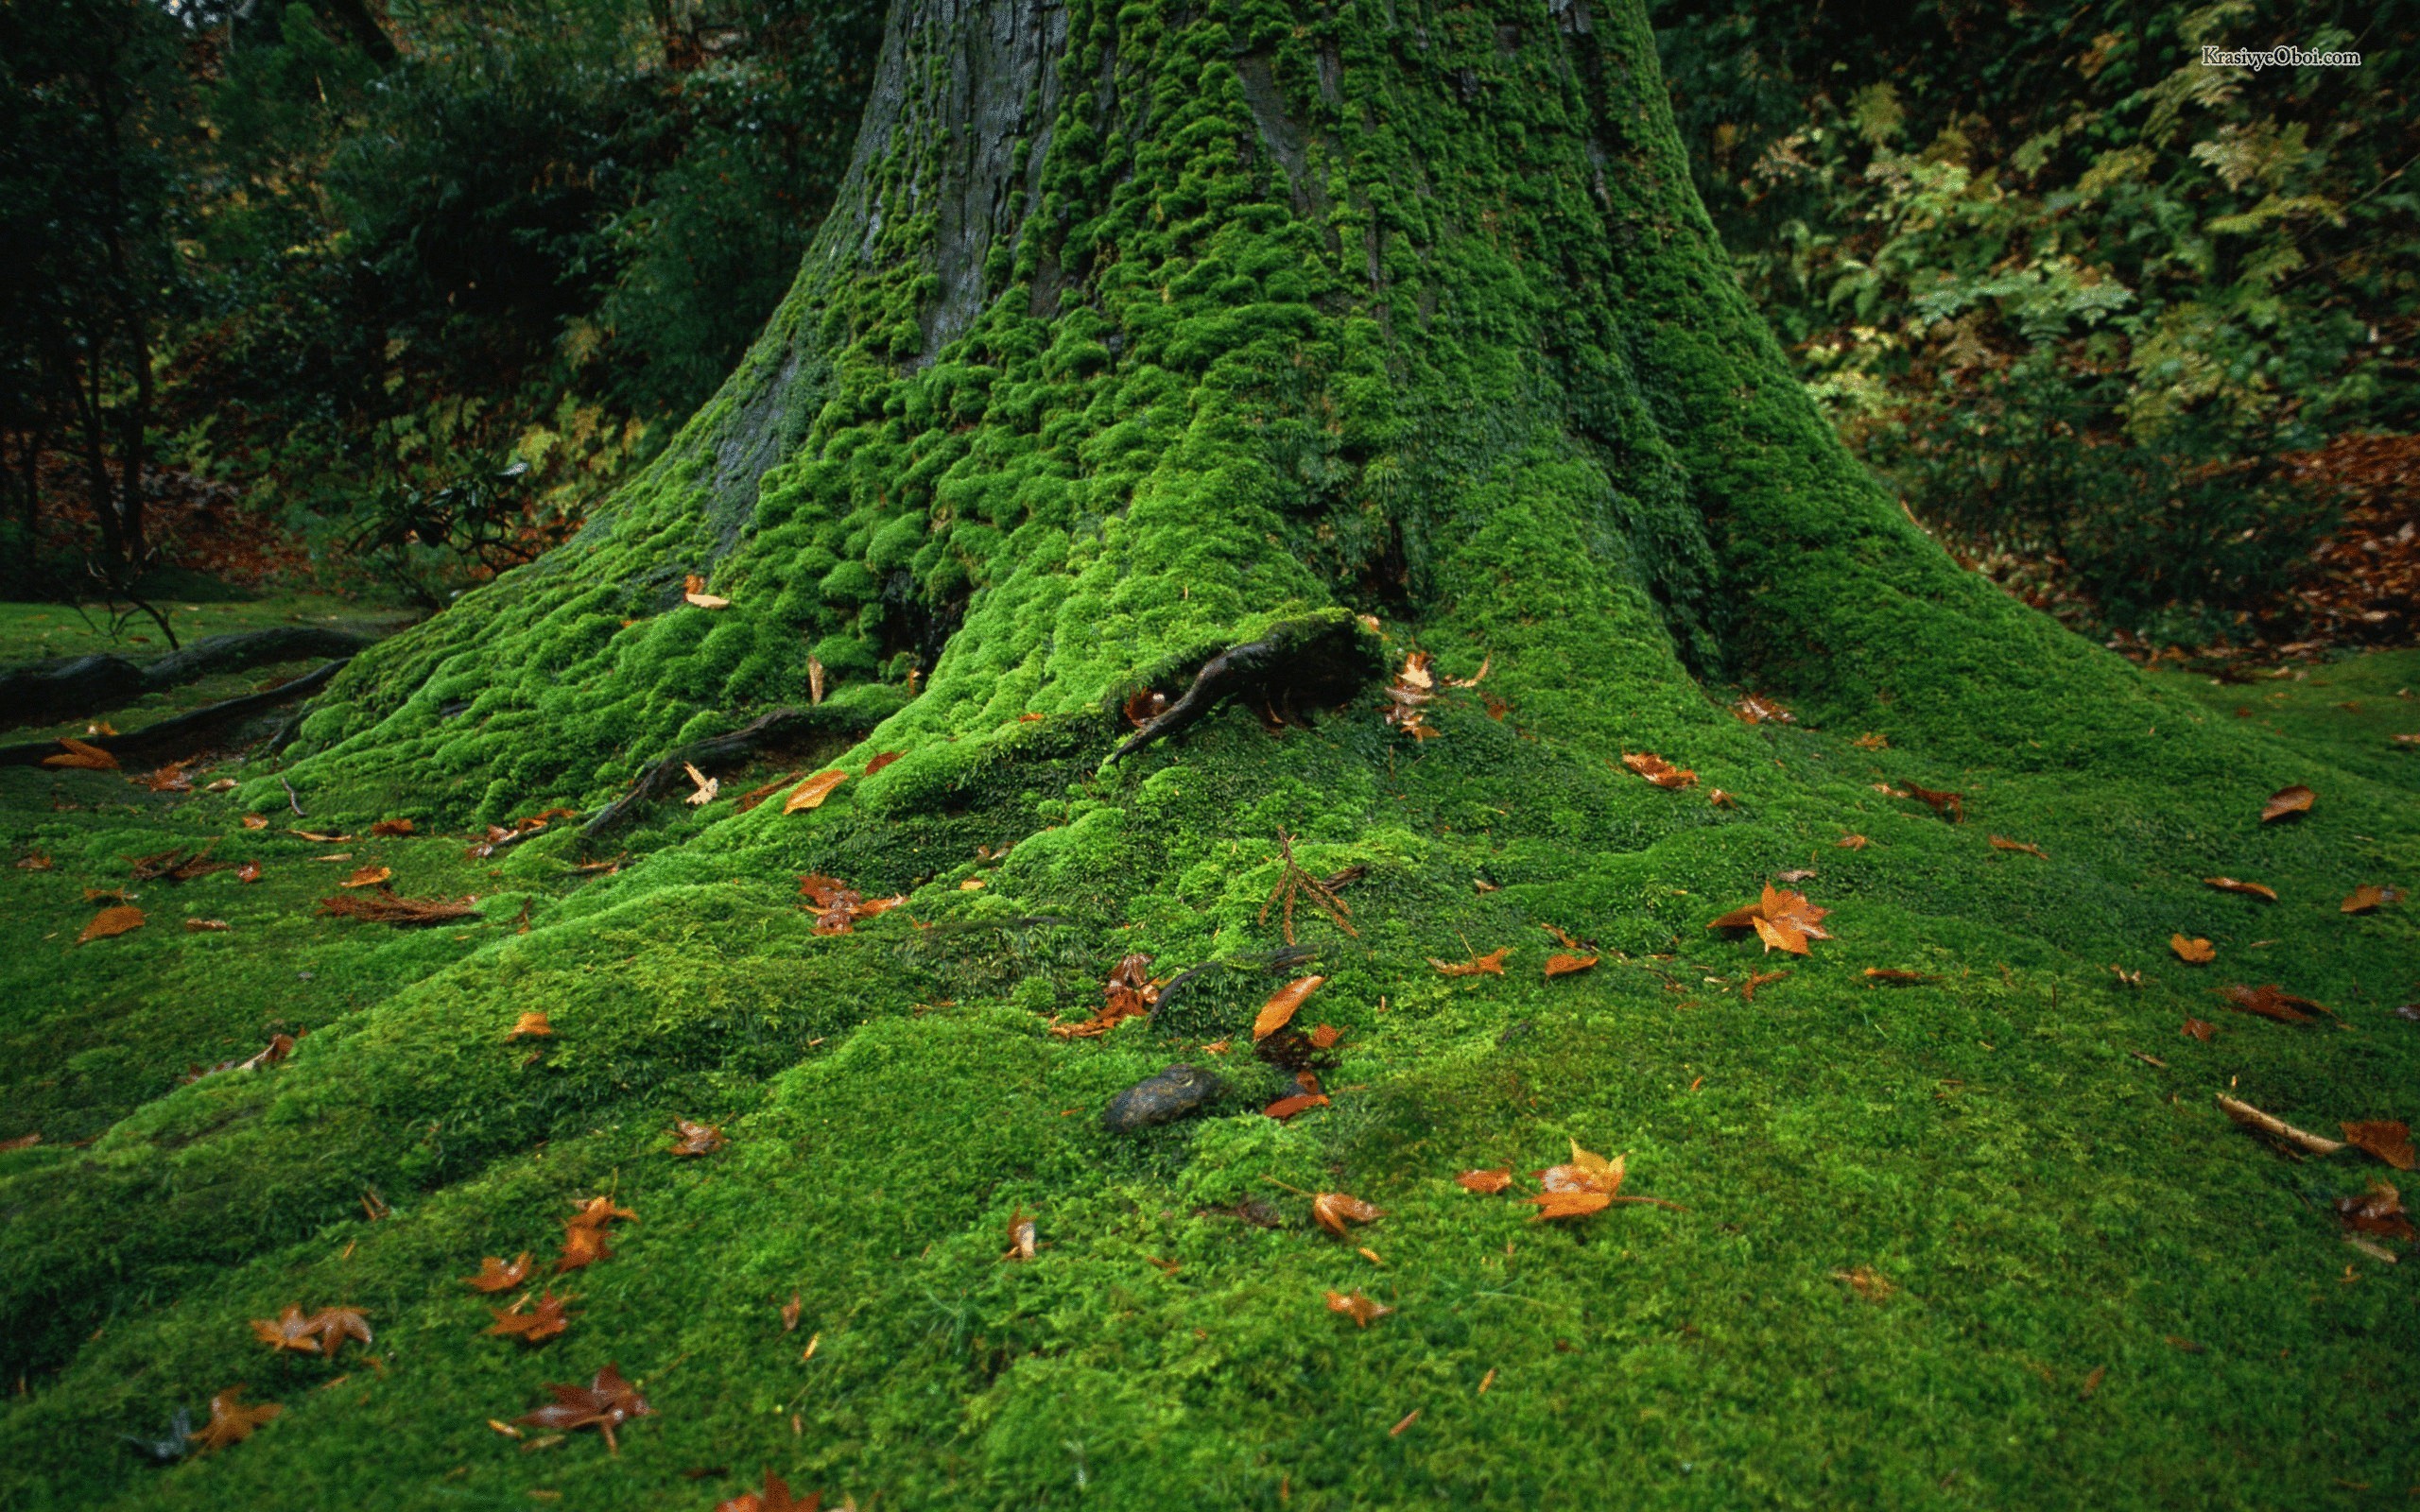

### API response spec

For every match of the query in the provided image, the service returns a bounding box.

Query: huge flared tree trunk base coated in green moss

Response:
[283,0,2158,820]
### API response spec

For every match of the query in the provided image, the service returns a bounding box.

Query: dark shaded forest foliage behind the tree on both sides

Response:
[0,0,2420,658]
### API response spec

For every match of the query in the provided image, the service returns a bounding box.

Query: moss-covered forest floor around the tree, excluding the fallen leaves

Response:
[0,602,2420,1512]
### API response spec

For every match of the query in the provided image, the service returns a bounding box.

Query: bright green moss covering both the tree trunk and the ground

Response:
[0,5,2420,1507]
